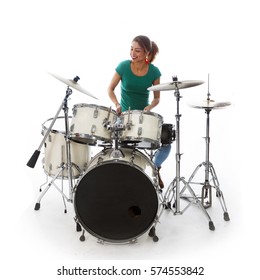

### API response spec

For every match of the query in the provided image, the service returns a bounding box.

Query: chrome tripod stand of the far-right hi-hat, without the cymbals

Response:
[188,93,230,221]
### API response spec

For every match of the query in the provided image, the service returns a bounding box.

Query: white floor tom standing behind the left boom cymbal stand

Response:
[42,117,90,179]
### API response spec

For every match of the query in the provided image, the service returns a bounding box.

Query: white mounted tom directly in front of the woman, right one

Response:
[120,110,163,147]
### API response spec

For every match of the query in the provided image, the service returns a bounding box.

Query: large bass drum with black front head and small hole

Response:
[74,148,159,243]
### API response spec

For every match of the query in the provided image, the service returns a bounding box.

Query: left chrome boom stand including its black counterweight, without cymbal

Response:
[27,76,79,212]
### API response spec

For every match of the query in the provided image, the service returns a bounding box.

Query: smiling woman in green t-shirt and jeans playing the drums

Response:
[108,35,171,188]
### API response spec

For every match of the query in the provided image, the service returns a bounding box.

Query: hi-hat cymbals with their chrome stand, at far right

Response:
[188,81,231,221]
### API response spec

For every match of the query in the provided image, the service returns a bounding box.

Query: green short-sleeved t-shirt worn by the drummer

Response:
[116,60,161,112]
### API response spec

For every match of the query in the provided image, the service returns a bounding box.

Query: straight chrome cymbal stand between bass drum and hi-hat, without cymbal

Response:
[163,77,215,230]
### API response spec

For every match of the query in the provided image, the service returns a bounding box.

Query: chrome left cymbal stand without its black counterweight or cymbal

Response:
[34,87,81,213]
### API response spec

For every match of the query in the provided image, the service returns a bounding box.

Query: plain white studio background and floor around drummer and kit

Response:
[0,0,260,279]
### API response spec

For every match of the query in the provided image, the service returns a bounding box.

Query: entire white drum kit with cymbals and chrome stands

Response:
[27,73,230,243]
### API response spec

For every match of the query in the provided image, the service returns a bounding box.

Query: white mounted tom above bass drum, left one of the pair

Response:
[70,103,116,144]
